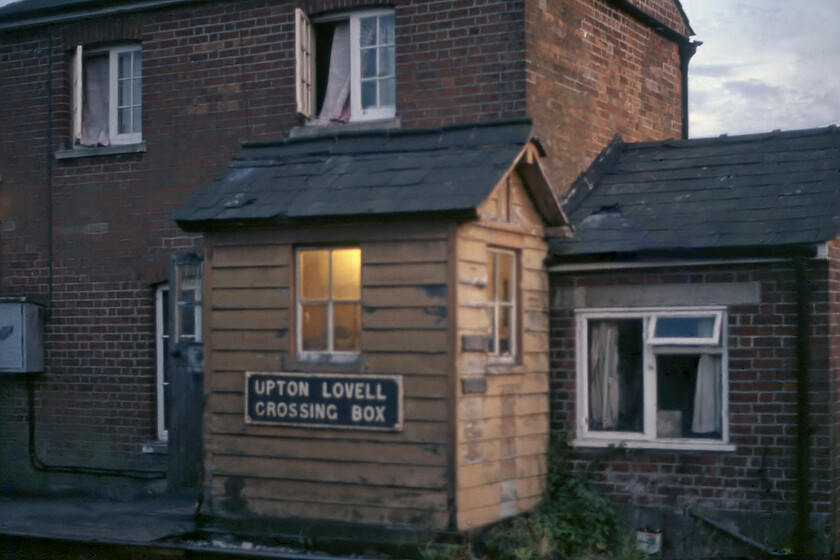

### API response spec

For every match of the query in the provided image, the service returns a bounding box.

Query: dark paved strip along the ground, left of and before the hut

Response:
[0,496,406,560]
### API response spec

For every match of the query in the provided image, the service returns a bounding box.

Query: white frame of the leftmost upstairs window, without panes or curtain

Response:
[73,43,143,146]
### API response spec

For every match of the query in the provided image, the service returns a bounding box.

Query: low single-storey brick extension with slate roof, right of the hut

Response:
[549,127,840,554]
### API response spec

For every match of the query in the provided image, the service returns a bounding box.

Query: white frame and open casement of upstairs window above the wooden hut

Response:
[295,8,397,122]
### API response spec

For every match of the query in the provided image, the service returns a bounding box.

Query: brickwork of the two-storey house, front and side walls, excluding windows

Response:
[0,0,678,486]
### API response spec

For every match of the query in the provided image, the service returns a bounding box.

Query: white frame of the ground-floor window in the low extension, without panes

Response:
[574,306,735,451]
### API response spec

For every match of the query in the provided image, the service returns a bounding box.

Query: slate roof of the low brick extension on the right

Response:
[551,126,840,257]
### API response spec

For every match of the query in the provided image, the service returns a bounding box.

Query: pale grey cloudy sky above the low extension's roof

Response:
[0,0,840,138]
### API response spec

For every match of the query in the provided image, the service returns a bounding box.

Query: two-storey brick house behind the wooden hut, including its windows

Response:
[0,0,694,540]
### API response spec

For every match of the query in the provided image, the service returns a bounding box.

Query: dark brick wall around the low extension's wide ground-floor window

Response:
[551,262,836,516]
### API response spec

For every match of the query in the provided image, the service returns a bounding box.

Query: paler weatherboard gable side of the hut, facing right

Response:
[455,171,549,530]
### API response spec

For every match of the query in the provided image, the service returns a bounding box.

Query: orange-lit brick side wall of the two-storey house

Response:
[525,0,683,193]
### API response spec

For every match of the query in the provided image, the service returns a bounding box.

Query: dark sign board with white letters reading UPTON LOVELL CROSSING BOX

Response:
[245,371,403,431]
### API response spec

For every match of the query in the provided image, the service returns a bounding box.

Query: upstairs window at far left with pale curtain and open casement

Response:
[73,44,143,147]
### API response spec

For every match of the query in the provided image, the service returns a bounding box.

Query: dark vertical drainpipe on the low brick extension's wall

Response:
[793,257,814,554]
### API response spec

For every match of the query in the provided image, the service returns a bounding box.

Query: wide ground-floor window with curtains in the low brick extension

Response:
[578,308,728,447]
